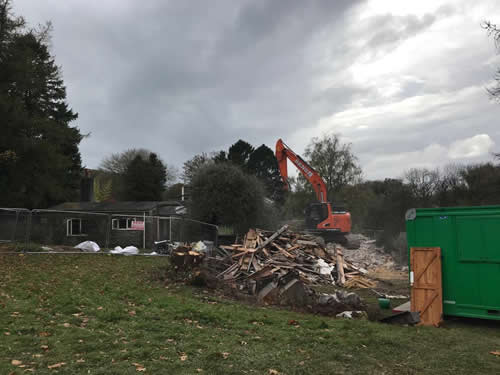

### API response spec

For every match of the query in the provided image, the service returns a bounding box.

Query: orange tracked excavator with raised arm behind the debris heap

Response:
[276,139,351,243]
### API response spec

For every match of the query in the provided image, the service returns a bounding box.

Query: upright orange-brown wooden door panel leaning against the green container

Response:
[410,247,443,327]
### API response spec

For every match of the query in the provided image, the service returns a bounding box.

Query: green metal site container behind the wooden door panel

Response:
[406,206,500,320]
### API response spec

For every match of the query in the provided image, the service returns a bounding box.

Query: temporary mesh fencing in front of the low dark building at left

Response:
[0,208,218,251]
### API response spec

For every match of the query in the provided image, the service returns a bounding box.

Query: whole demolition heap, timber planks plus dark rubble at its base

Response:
[195,225,374,315]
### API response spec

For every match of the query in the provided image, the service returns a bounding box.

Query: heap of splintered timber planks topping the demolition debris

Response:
[210,225,372,288]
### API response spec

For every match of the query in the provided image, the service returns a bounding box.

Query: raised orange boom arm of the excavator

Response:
[276,139,328,202]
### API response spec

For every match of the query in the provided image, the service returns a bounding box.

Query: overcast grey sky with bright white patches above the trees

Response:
[10,0,500,179]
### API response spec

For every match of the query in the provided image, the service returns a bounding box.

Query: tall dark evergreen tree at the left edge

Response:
[0,0,82,208]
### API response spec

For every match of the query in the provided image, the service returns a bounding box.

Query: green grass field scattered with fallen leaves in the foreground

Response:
[0,255,500,374]
